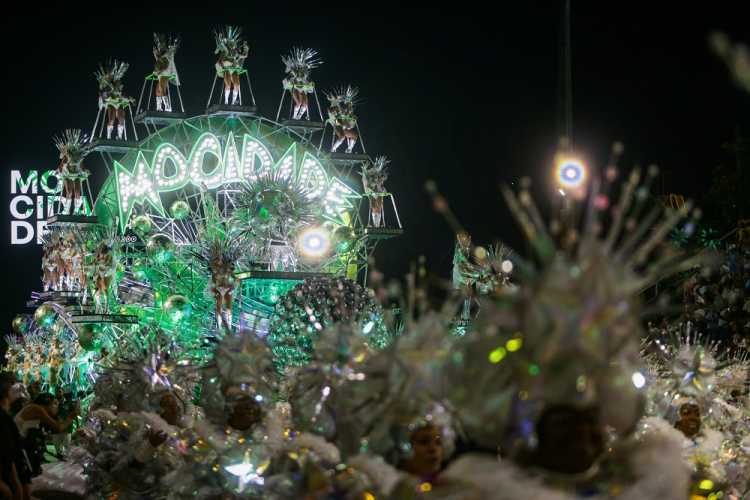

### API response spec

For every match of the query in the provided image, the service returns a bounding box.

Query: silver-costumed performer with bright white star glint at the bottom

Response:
[164,330,290,498]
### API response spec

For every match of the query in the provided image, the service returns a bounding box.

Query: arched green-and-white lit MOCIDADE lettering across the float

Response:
[114,132,360,231]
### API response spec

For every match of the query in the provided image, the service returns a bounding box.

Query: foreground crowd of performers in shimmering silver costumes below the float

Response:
[0,167,750,500]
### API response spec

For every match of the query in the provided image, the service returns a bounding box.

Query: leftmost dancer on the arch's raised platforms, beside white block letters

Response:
[55,129,91,215]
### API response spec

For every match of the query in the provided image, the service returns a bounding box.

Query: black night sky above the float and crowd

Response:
[0,0,750,340]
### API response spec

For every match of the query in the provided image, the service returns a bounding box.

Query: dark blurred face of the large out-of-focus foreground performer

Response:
[536,406,604,474]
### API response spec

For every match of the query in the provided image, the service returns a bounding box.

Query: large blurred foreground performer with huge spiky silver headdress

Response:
[441,162,704,500]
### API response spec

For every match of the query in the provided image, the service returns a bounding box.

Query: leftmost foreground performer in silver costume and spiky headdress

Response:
[86,325,198,499]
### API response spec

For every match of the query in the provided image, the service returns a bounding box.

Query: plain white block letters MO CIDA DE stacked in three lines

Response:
[10,170,91,245]
